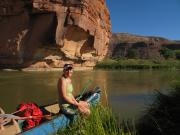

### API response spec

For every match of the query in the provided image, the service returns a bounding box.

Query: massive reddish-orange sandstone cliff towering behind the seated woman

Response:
[0,0,111,68]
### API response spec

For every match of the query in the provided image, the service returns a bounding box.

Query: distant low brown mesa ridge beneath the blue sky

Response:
[108,33,180,59]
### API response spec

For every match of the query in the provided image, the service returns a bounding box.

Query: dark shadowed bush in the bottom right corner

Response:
[136,81,180,135]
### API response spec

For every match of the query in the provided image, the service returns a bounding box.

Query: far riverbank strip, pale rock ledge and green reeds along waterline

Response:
[1,59,180,72]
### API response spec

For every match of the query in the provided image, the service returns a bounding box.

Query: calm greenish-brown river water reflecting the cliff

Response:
[0,70,180,118]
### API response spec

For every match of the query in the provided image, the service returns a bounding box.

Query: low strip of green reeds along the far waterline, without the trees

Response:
[95,59,180,69]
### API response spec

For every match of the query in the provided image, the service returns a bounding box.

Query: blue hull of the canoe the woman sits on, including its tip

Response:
[18,89,101,135]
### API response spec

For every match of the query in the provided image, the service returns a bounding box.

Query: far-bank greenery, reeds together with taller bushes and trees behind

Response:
[101,46,180,69]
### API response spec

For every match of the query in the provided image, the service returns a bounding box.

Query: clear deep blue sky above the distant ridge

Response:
[106,0,180,40]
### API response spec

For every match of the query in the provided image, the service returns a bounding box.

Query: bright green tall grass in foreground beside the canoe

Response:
[58,105,136,135]
